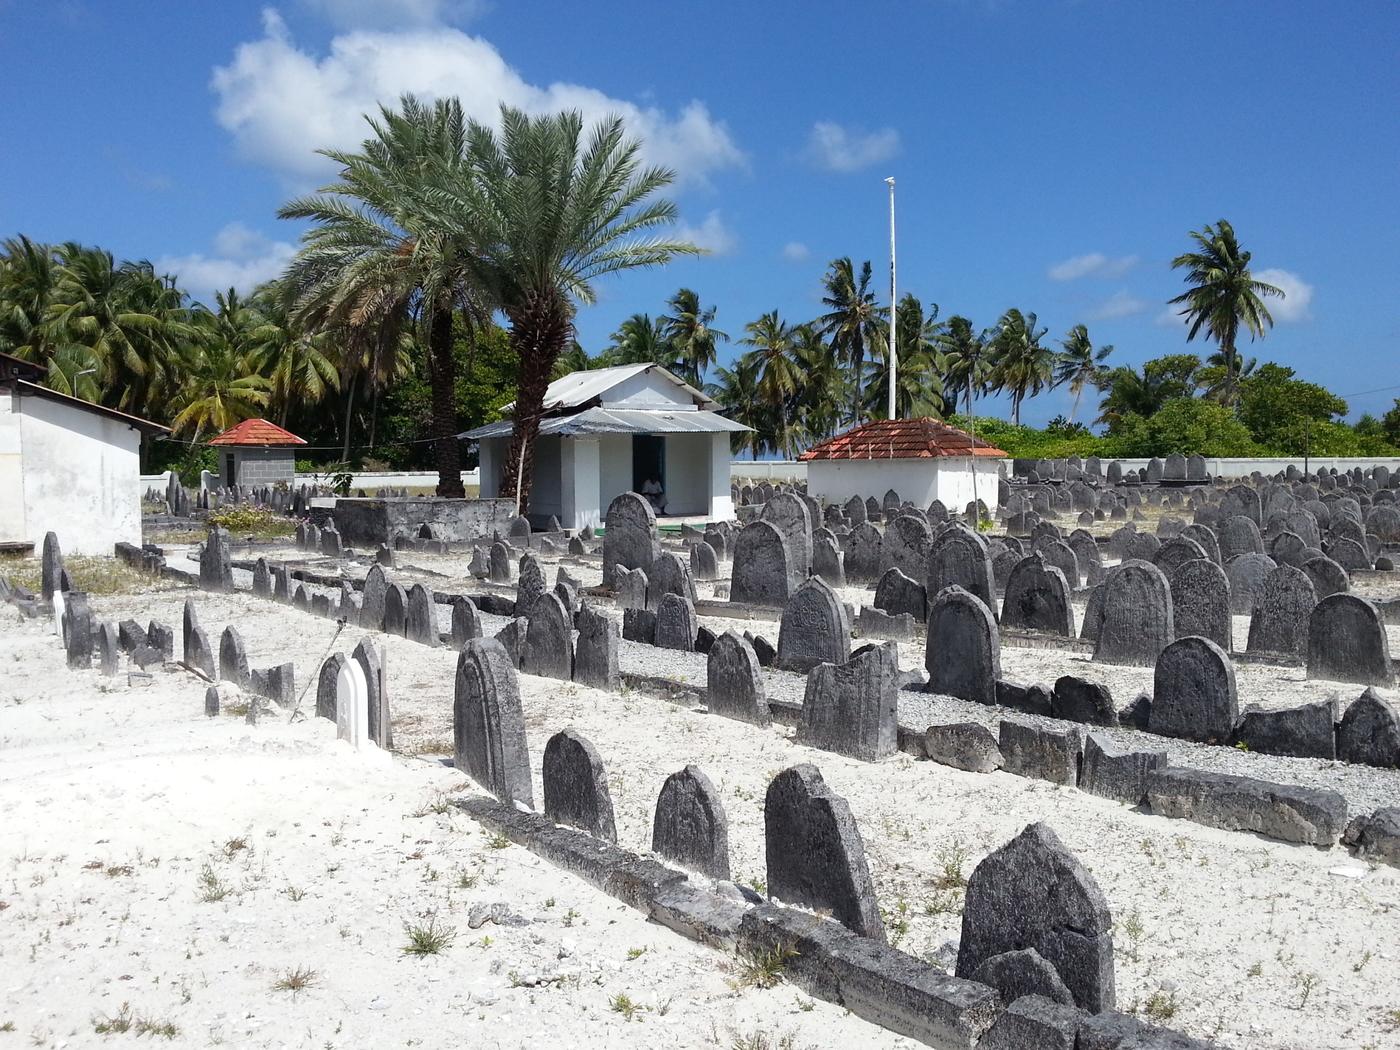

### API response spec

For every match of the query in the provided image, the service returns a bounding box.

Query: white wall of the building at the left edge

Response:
[18,396,141,554]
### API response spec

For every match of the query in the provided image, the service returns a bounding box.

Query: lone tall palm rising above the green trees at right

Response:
[1169,218,1284,405]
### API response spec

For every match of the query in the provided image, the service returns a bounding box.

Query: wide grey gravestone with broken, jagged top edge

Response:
[797,643,899,762]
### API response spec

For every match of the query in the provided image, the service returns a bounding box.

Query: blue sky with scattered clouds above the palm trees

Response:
[0,0,1400,423]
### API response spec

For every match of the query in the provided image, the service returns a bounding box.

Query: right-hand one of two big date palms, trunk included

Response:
[450,106,700,512]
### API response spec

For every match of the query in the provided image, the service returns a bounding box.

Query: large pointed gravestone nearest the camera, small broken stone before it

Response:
[956,823,1114,1014]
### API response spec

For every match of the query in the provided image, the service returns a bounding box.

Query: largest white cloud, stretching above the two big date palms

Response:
[211,8,743,182]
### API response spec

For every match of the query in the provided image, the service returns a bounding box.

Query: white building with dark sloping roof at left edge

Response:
[0,354,167,554]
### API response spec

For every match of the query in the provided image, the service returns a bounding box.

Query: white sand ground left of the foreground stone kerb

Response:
[0,596,911,1049]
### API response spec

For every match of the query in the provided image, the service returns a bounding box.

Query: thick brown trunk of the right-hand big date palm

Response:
[500,291,573,514]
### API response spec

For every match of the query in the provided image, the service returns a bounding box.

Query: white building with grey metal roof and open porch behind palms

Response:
[458,364,748,529]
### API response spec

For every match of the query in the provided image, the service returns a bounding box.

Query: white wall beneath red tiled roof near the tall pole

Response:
[806,456,1002,511]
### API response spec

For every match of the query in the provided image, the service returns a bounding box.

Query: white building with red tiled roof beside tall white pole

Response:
[798,417,1007,511]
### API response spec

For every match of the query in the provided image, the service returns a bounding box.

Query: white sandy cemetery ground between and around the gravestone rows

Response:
[0,549,1400,1050]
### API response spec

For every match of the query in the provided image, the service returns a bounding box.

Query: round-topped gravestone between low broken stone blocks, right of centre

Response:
[1148,637,1239,742]
